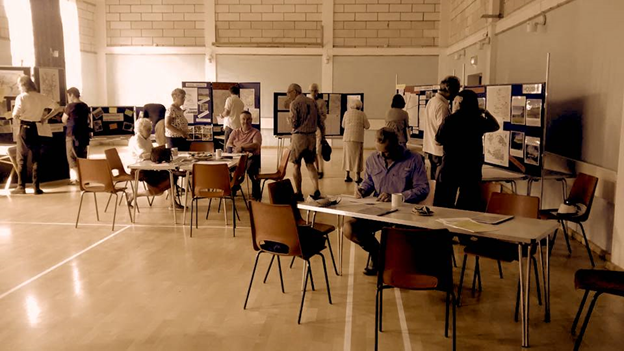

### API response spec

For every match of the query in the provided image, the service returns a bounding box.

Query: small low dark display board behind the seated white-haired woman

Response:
[91,106,135,136]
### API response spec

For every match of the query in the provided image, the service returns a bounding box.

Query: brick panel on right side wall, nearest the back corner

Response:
[449,0,488,44]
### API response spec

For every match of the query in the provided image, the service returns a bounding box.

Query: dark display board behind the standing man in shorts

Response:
[273,93,364,136]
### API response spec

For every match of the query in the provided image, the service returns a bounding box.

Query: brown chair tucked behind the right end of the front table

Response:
[457,193,542,320]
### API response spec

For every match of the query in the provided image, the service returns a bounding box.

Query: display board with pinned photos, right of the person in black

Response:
[464,83,546,177]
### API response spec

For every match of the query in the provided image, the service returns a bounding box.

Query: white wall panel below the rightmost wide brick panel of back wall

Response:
[334,56,438,148]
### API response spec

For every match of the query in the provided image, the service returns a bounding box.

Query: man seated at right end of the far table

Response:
[226,111,262,200]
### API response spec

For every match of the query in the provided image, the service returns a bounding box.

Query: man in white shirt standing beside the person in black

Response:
[423,76,460,180]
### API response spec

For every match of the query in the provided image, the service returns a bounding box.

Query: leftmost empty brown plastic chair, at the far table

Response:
[76,158,132,230]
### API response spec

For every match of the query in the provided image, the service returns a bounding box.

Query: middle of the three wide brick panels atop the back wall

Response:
[215,0,323,45]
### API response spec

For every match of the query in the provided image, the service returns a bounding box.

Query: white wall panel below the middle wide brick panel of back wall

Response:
[215,55,322,146]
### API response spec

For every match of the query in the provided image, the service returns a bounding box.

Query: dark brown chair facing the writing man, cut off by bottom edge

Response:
[375,228,456,350]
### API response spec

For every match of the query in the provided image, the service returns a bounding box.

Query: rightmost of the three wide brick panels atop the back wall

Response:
[334,0,446,47]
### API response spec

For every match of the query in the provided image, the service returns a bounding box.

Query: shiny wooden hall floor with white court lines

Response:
[0,150,624,350]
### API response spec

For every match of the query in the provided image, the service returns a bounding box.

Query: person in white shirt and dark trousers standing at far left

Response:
[11,75,63,195]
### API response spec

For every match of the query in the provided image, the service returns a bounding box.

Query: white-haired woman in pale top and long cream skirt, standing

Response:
[342,100,370,183]
